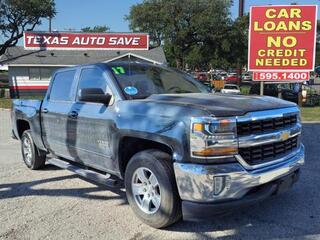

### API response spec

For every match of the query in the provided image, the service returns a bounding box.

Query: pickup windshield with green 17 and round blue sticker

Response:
[108,63,209,99]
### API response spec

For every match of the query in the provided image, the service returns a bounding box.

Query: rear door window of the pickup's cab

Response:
[50,70,76,101]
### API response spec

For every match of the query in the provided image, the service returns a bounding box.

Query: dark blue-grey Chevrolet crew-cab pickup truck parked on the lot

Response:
[12,61,304,228]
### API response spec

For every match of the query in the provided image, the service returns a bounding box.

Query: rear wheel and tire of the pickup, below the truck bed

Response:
[21,130,46,170]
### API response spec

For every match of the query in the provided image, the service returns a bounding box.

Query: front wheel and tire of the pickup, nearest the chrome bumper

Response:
[125,149,181,228]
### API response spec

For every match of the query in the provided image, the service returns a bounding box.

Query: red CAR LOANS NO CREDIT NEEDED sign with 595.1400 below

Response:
[248,5,317,81]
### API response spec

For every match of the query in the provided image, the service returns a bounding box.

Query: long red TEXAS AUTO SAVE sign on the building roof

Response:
[24,32,149,50]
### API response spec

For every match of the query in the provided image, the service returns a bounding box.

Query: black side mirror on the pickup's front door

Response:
[79,88,112,105]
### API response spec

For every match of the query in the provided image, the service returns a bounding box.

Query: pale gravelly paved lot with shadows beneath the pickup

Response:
[0,110,320,240]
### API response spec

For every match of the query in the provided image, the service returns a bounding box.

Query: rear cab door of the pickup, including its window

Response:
[41,69,77,159]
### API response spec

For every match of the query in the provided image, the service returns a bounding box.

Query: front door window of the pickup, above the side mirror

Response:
[78,68,107,92]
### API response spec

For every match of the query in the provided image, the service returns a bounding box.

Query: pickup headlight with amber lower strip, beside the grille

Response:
[190,117,238,158]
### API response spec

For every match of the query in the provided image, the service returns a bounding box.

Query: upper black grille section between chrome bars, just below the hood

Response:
[237,114,297,137]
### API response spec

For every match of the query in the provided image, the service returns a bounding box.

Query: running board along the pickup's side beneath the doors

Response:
[47,158,118,187]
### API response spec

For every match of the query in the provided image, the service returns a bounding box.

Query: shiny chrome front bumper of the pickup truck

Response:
[174,144,304,202]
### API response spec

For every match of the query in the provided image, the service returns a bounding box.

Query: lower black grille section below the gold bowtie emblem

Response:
[239,136,298,165]
